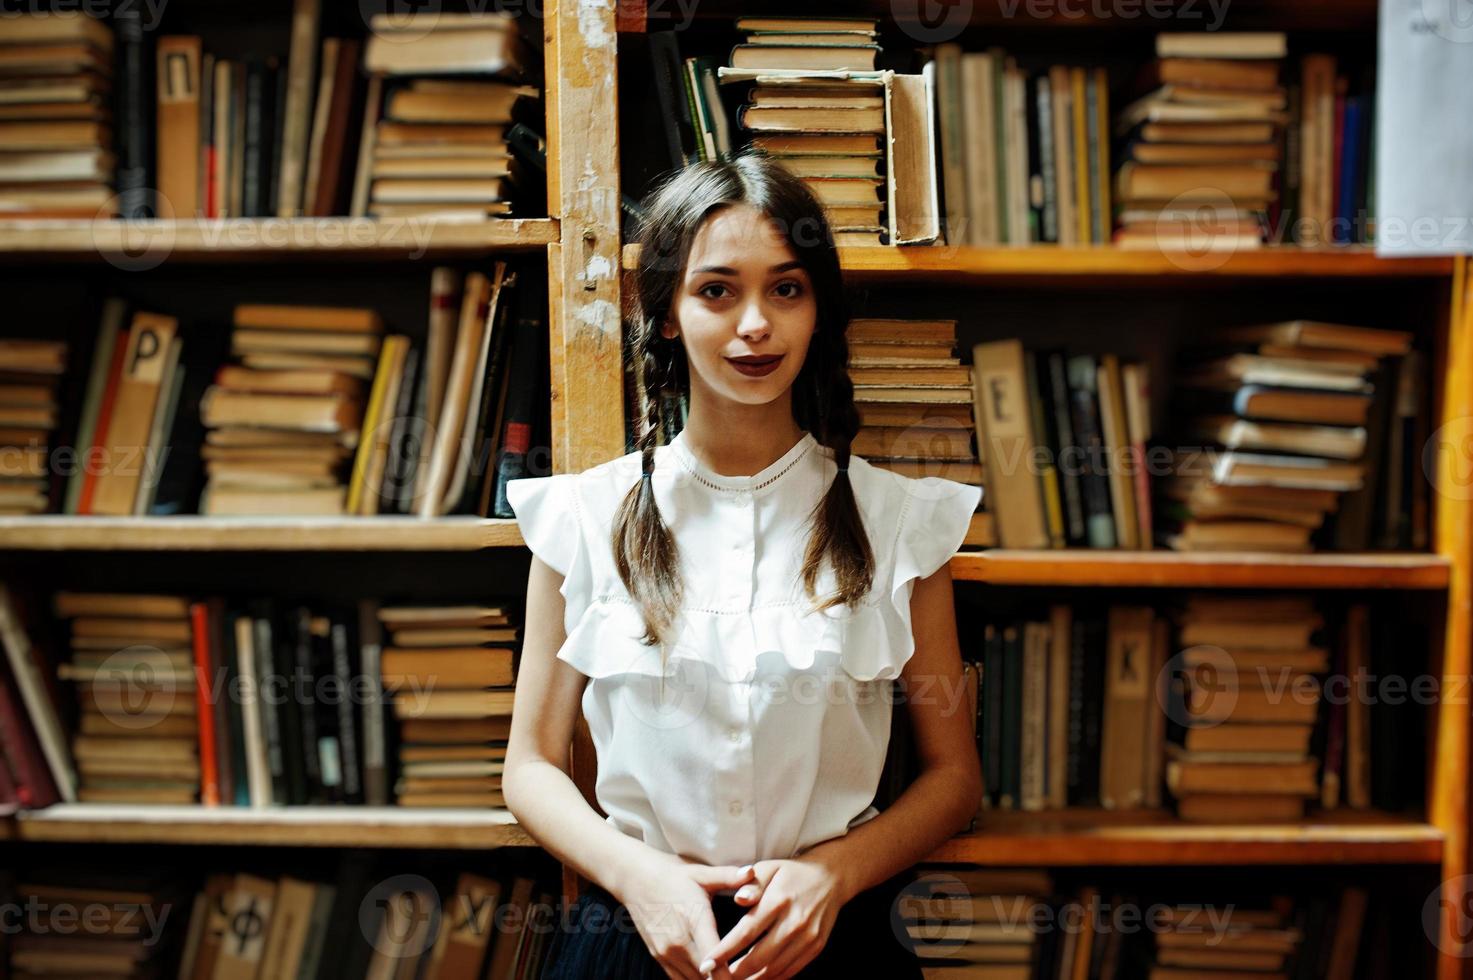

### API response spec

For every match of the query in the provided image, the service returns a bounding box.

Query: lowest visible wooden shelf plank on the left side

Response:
[9,803,536,849]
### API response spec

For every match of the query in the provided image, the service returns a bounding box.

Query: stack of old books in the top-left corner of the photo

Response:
[0,10,118,218]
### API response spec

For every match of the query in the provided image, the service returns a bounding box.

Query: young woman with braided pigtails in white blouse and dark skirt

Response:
[504,147,981,980]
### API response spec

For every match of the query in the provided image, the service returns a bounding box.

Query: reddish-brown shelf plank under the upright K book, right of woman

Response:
[927,809,1444,867]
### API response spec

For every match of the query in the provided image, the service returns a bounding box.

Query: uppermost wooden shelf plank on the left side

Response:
[0,218,560,262]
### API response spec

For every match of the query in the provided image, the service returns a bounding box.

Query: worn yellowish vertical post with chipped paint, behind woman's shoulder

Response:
[545,0,625,473]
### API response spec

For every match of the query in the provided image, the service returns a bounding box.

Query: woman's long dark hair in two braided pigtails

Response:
[611,150,873,644]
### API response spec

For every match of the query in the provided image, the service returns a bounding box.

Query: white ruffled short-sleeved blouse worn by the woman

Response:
[507,432,981,865]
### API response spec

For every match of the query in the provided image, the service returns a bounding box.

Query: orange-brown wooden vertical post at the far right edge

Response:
[1427,256,1473,980]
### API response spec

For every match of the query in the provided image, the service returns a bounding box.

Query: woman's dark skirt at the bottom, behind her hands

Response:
[541,872,922,980]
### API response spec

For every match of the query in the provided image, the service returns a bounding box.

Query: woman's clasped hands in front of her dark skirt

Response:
[620,855,853,980]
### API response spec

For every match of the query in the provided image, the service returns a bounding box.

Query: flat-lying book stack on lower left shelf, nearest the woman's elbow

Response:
[379,606,517,808]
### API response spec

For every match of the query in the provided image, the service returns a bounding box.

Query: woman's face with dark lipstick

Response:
[661,205,818,405]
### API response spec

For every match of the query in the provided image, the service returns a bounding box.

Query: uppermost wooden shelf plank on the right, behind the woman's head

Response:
[622,245,1452,284]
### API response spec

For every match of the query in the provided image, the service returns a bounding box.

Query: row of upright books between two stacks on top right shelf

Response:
[935,43,1111,246]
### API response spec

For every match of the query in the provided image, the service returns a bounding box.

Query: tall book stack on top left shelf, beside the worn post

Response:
[362,10,541,220]
